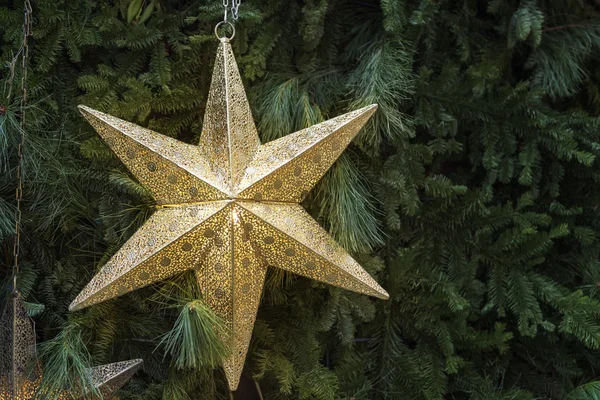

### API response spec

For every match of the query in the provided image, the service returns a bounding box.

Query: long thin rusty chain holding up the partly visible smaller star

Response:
[12,0,33,293]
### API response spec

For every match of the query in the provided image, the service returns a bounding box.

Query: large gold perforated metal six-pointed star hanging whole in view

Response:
[70,39,388,390]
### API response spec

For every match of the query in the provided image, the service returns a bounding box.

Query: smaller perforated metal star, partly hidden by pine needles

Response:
[0,293,142,400]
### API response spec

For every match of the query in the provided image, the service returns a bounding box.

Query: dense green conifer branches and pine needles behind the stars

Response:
[0,0,600,400]
